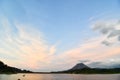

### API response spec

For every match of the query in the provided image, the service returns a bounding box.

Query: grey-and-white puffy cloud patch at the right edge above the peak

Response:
[93,20,120,46]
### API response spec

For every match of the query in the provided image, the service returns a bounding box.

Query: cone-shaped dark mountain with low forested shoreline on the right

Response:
[52,63,120,74]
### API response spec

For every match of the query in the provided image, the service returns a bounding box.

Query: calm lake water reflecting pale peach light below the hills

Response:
[0,74,120,80]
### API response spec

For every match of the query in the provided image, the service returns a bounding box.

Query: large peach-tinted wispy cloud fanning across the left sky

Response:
[0,17,56,69]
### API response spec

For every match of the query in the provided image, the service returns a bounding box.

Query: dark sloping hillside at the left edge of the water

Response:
[0,61,31,73]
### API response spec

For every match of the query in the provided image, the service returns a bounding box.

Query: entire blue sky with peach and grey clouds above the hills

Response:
[0,0,120,72]
